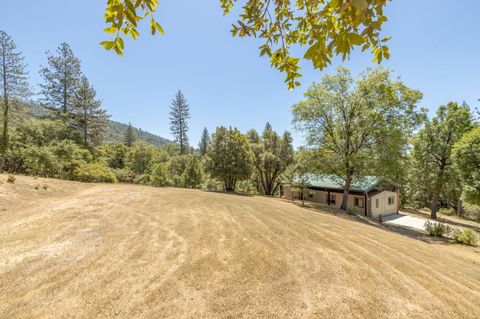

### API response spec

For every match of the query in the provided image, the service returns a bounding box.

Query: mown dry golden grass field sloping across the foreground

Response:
[0,175,480,319]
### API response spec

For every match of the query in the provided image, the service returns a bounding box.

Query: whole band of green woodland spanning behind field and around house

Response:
[0,31,480,218]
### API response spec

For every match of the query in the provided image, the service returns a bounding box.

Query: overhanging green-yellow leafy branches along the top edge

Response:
[101,0,390,89]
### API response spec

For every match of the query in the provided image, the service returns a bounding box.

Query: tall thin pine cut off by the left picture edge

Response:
[0,31,29,153]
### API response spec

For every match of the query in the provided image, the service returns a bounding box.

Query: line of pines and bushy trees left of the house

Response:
[0,32,294,195]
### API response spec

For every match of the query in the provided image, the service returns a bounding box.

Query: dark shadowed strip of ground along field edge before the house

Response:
[286,200,456,245]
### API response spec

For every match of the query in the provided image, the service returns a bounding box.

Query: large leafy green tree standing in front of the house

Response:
[292,68,423,209]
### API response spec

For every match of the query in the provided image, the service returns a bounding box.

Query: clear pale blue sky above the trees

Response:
[0,0,480,146]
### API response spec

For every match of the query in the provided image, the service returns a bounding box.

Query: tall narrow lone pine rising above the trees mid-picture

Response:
[170,91,190,154]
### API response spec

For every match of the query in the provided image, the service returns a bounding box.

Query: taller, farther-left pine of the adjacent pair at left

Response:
[40,43,82,121]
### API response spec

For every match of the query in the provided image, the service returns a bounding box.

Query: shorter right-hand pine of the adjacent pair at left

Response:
[73,76,109,146]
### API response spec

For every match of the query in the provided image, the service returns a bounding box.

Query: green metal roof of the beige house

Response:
[297,174,388,192]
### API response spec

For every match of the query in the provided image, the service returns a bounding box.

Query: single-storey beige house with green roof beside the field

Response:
[280,174,400,218]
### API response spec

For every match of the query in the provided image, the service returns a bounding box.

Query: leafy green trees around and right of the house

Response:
[292,68,480,219]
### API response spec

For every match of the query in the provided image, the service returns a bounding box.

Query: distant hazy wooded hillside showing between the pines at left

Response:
[27,102,172,146]
